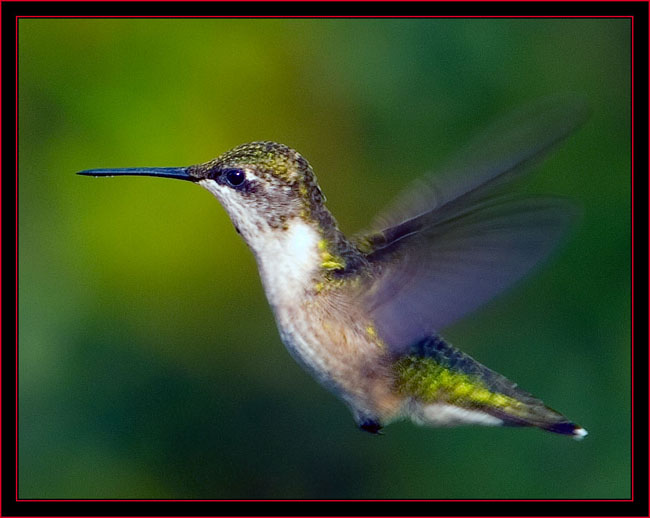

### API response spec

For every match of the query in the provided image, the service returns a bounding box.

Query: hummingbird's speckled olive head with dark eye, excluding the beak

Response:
[187,141,325,238]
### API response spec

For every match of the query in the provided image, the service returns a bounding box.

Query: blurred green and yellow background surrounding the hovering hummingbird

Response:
[19,19,631,498]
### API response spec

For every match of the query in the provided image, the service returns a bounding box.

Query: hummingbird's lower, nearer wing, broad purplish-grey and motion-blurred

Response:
[367,197,573,351]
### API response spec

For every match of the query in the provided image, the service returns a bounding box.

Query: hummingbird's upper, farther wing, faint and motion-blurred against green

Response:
[364,95,589,230]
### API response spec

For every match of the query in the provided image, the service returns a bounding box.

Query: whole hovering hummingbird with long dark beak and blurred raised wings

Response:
[78,97,588,439]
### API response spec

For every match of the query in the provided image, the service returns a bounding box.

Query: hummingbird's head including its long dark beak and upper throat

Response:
[79,142,343,272]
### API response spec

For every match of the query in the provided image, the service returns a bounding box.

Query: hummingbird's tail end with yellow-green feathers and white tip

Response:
[395,336,587,439]
